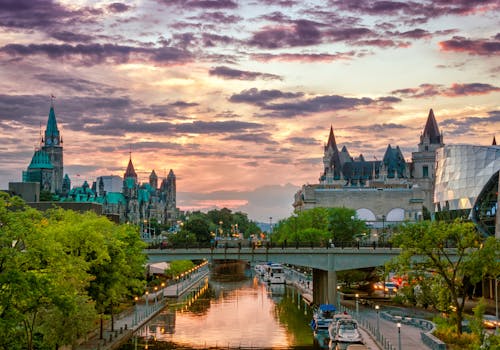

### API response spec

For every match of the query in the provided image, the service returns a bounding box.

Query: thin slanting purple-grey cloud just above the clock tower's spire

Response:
[34,73,124,95]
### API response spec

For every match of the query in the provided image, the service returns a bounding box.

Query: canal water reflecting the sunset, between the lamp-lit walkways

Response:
[120,269,315,350]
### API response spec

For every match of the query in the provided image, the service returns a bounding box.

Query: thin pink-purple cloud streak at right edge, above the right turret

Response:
[391,83,500,98]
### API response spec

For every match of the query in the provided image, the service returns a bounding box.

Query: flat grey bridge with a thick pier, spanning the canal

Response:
[144,246,401,304]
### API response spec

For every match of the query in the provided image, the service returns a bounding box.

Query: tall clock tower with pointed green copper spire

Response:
[42,100,63,194]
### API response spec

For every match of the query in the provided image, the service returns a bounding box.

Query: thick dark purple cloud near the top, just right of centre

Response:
[247,20,321,49]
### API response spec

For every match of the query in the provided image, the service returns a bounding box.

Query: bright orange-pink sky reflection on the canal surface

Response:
[154,279,290,348]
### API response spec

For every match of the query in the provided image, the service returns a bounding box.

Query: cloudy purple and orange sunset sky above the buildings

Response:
[0,0,500,222]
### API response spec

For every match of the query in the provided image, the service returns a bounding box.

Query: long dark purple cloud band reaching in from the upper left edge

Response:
[0,44,192,66]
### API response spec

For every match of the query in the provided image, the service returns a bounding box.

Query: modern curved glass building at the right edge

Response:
[434,145,500,236]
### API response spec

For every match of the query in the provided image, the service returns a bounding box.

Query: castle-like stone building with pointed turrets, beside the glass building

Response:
[293,109,444,228]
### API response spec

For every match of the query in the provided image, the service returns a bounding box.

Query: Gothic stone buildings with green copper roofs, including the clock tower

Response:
[9,103,178,225]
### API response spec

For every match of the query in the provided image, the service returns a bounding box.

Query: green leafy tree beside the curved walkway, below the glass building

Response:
[390,220,500,333]
